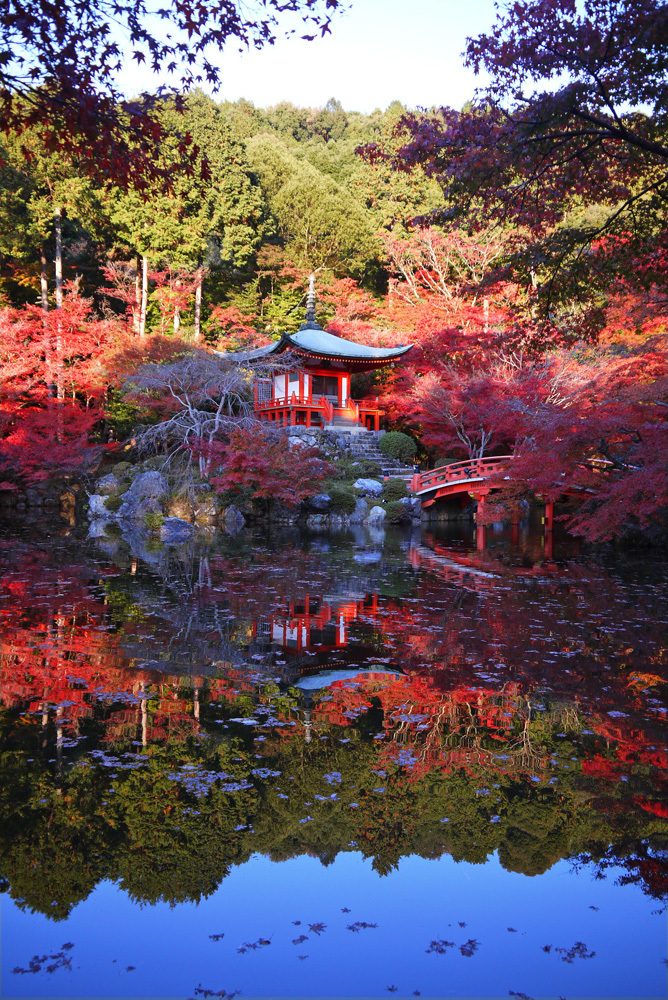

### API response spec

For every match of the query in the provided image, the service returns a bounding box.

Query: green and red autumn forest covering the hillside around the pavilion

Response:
[0,3,668,541]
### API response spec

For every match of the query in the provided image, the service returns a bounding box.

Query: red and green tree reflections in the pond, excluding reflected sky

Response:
[0,543,668,916]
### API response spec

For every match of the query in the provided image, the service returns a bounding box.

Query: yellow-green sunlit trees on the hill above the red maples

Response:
[0,92,442,312]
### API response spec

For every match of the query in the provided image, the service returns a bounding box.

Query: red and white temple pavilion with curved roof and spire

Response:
[240,275,413,431]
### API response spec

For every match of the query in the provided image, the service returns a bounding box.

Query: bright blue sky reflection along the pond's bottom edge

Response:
[3,854,666,998]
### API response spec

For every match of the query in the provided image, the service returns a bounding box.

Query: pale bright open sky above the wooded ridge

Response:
[124,0,494,112]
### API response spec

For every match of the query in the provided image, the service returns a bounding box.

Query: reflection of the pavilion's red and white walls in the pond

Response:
[253,594,378,653]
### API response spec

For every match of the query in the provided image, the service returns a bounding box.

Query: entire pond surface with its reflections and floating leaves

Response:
[0,512,668,998]
